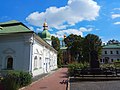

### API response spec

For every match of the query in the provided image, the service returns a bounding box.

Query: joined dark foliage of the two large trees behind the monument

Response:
[64,34,102,62]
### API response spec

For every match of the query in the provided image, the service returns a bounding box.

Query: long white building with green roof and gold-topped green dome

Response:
[0,21,57,77]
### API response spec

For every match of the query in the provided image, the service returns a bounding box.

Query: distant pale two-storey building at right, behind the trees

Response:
[100,44,120,63]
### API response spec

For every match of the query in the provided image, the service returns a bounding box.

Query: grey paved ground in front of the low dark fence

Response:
[70,80,120,90]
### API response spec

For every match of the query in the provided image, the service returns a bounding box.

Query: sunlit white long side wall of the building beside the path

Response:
[32,35,57,76]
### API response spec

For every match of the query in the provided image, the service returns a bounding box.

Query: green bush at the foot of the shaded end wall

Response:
[2,71,32,90]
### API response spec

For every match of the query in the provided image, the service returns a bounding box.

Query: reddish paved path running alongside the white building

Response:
[21,68,68,90]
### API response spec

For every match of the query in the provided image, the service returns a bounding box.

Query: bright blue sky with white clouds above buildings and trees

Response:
[0,0,120,42]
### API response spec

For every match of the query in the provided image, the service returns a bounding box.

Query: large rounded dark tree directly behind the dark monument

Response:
[82,34,102,62]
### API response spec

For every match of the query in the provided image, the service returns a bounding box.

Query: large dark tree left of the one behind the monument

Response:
[64,34,83,62]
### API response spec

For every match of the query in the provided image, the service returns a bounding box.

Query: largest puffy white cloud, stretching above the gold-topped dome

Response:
[26,0,100,29]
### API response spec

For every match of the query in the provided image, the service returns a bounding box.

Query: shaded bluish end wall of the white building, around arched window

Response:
[0,34,31,71]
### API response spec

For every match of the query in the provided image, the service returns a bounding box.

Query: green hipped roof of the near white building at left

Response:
[0,20,33,35]
